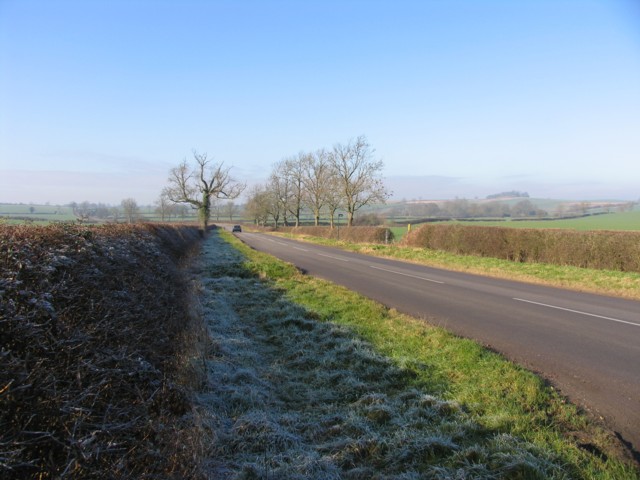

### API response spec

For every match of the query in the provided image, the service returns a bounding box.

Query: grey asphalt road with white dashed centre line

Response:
[238,233,640,457]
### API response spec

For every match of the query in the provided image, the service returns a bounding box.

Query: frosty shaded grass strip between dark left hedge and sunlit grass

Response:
[194,235,569,479]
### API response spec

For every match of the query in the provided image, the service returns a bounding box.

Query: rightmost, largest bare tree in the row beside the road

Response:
[329,136,389,226]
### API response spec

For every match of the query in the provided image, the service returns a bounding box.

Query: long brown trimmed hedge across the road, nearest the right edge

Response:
[402,225,640,272]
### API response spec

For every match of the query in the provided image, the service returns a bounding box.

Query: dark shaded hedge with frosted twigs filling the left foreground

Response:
[0,224,204,479]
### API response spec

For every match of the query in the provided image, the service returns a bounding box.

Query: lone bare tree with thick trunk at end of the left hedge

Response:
[164,150,245,233]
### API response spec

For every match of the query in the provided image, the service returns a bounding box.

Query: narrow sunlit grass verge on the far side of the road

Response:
[268,234,640,300]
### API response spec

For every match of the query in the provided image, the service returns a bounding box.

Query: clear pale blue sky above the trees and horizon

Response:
[0,0,640,205]
